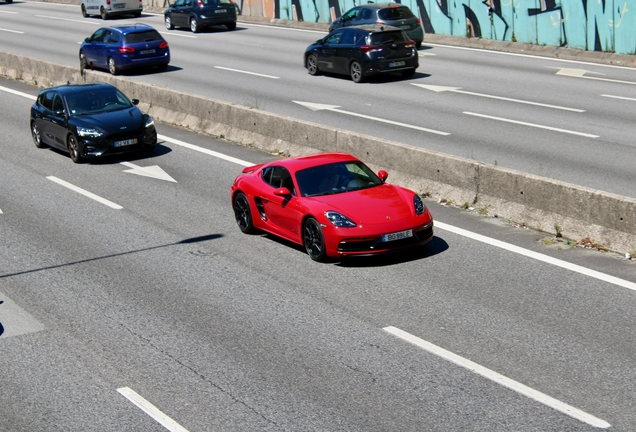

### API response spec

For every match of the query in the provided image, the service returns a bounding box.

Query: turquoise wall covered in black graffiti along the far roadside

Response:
[236,0,636,54]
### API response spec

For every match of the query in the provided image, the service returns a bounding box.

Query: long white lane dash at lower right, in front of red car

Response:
[383,326,612,429]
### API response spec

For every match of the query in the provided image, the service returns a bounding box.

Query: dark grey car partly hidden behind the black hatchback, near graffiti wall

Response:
[329,3,424,48]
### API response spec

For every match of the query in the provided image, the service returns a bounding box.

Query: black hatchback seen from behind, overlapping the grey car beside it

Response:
[304,25,419,83]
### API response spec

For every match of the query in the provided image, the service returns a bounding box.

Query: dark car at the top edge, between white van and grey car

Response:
[163,0,237,33]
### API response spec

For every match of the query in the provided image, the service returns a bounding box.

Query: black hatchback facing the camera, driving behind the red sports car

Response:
[30,83,157,163]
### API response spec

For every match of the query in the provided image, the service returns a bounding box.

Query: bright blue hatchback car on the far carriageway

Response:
[79,24,170,75]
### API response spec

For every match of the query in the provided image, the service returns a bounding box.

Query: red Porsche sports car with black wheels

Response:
[231,153,433,261]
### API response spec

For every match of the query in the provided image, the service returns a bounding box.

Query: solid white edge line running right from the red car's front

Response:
[435,221,636,291]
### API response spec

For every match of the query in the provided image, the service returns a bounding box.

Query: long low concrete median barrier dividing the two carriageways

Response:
[0,52,636,253]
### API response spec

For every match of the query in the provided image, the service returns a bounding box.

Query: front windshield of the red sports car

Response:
[296,161,382,197]
